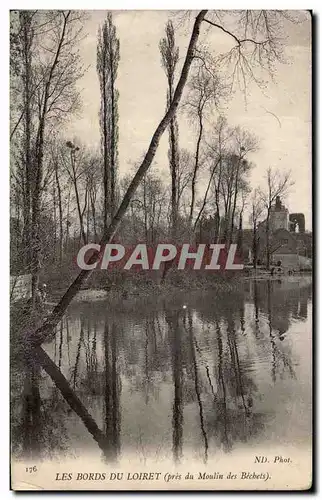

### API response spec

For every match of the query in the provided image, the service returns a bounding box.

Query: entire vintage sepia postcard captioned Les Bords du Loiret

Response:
[10,10,313,491]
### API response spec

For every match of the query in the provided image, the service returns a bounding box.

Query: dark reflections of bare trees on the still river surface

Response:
[11,281,311,463]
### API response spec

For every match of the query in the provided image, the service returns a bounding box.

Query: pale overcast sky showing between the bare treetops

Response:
[68,11,312,229]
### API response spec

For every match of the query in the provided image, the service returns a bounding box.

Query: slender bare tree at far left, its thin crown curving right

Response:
[31,11,83,297]
